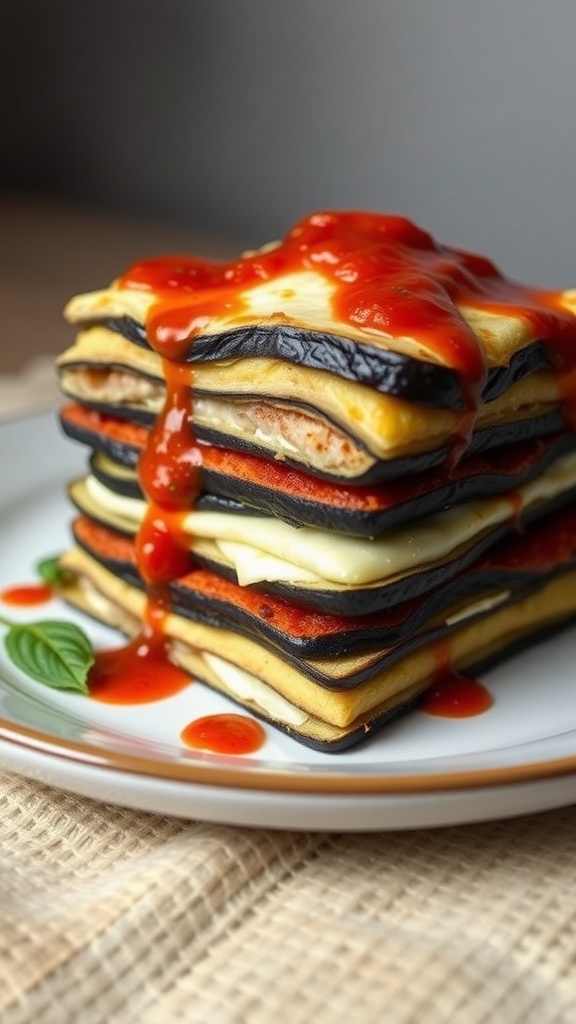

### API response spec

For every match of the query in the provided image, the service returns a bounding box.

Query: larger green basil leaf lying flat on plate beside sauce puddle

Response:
[4,620,94,693]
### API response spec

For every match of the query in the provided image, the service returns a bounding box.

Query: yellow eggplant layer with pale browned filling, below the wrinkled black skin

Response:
[58,326,565,483]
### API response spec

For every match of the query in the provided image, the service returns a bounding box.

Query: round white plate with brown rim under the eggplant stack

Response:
[0,414,576,830]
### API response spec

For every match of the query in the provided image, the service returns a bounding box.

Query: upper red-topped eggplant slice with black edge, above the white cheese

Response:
[66,406,576,537]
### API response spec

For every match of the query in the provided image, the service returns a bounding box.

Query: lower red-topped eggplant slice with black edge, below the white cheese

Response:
[73,504,576,659]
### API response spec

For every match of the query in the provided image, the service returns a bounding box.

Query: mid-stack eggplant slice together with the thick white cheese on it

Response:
[70,444,576,615]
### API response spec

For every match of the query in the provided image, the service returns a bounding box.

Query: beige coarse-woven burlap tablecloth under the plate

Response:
[0,203,576,1024]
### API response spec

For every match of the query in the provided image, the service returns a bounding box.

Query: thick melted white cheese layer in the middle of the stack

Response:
[81,453,576,586]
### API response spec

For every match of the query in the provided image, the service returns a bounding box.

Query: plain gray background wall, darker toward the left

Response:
[0,0,576,285]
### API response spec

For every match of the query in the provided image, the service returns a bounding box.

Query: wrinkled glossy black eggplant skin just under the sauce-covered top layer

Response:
[105,316,551,411]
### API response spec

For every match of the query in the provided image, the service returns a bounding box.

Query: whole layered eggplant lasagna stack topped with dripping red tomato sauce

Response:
[58,212,576,751]
